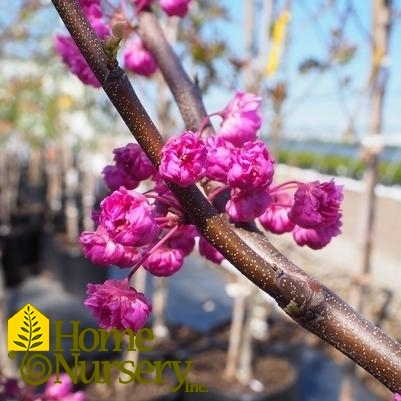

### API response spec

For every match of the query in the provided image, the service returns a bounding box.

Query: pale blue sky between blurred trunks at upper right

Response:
[211,0,401,140]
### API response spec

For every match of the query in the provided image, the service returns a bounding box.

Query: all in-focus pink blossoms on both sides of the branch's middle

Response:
[80,92,342,332]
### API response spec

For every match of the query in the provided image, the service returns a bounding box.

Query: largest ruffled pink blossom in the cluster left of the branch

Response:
[99,187,159,246]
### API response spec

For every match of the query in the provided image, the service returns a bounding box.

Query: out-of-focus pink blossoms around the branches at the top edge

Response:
[55,0,191,84]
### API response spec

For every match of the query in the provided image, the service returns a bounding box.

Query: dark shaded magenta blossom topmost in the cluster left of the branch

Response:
[113,143,156,181]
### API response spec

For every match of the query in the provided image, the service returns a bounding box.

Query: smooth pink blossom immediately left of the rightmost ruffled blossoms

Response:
[259,191,295,234]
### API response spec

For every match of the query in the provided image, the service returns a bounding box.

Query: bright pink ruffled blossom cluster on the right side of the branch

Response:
[159,92,342,249]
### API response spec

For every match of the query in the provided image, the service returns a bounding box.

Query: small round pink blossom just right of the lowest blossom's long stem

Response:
[143,244,185,277]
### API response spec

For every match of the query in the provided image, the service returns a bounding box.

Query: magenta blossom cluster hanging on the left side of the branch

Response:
[80,143,211,332]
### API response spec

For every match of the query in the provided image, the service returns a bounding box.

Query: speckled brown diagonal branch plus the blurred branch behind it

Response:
[52,0,401,392]
